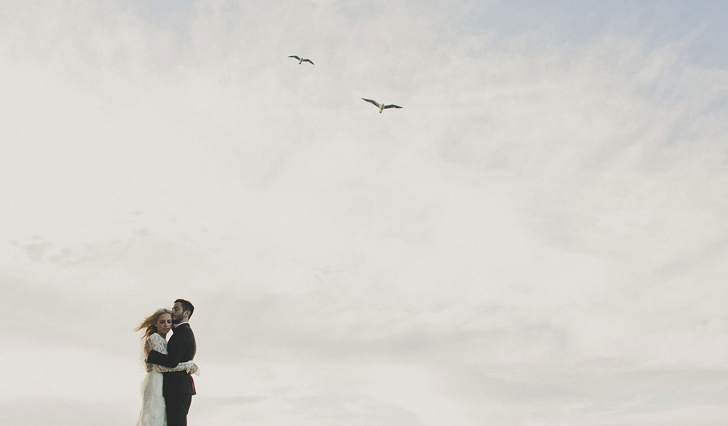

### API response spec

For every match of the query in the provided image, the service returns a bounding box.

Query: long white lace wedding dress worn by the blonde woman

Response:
[137,333,197,426]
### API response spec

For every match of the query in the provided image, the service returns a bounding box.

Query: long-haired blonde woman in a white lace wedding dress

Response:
[135,309,200,426]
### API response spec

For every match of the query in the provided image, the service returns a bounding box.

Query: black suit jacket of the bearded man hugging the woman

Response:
[147,323,197,396]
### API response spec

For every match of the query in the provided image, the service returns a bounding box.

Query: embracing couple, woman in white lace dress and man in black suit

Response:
[136,299,200,426]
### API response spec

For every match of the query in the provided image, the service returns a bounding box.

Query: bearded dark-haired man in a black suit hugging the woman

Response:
[147,299,197,426]
